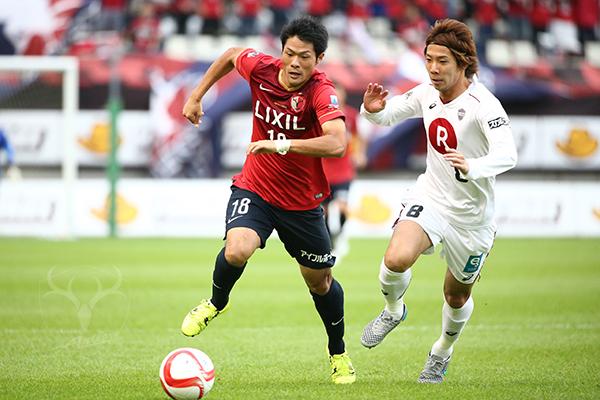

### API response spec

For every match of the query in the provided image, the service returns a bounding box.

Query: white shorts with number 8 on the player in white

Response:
[398,198,496,284]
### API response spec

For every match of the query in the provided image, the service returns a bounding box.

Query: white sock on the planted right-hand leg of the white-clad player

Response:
[431,297,475,358]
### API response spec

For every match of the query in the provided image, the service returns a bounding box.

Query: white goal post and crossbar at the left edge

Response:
[0,56,79,237]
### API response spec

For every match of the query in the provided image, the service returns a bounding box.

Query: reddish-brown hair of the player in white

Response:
[424,18,479,79]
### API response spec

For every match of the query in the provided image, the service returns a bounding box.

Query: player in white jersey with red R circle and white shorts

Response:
[361,19,517,383]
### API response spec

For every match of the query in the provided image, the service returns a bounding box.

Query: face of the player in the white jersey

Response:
[425,44,468,100]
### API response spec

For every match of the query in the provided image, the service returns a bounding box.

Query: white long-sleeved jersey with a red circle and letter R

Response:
[361,81,517,228]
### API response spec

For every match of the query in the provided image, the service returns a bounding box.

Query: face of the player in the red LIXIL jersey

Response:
[281,36,323,90]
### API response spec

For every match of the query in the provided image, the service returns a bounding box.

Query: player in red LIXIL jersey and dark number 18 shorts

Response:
[181,17,356,383]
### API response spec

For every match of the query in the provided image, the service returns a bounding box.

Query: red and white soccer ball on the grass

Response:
[159,347,215,400]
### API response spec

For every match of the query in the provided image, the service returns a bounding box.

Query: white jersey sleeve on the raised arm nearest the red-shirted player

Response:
[360,84,427,126]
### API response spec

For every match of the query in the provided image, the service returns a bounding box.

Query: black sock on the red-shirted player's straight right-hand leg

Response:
[310,279,346,354]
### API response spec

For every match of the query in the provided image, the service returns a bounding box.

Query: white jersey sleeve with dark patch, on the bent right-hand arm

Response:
[466,98,517,179]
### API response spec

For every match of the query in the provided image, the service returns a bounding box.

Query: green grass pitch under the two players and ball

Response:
[0,239,600,400]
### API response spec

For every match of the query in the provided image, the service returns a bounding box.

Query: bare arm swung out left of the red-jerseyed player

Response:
[181,47,244,126]
